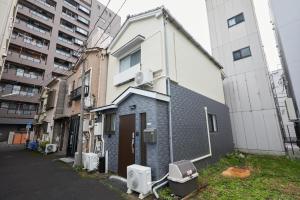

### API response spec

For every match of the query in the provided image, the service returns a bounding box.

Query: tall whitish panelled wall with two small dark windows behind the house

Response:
[206,0,284,154]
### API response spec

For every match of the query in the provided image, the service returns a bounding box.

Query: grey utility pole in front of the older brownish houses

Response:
[74,41,87,167]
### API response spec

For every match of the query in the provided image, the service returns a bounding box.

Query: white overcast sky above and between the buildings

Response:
[98,0,280,70]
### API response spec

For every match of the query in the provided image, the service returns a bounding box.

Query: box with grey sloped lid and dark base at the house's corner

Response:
[168,160,198,197]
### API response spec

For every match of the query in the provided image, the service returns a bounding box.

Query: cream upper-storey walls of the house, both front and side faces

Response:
[106,11,225,104]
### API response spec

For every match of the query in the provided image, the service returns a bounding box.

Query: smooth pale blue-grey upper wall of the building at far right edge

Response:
[270,0,300,117]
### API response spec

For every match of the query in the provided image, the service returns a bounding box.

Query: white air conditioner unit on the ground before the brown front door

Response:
[127,164,151,199]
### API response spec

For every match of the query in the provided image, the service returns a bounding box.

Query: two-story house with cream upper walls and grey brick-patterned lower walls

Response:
[91,7,233,179]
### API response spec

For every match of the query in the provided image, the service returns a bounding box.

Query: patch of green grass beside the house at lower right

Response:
[160,152,300,200]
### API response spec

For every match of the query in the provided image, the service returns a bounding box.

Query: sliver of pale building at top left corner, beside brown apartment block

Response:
[0,0,17,79]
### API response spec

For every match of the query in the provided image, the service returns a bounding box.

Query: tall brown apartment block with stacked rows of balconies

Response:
[0,0,121,140]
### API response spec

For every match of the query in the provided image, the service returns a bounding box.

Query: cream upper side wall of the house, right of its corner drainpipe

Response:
[166,23,225,104]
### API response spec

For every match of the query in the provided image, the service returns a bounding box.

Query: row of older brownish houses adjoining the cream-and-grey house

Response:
[34,47,107,156]
